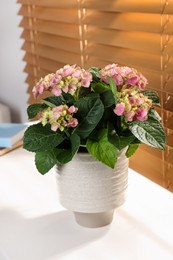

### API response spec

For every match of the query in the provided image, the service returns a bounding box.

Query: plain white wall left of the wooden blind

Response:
[0,0,28,122]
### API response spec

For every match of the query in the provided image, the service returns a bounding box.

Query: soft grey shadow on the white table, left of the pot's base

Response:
[0,210,109,260]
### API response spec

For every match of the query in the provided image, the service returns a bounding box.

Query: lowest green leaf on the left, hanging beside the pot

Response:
[35,148,57,174]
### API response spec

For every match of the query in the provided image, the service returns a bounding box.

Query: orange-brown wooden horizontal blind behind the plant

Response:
[18,0,173,190]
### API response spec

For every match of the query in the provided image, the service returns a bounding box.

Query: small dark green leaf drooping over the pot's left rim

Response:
[57,134,80,164]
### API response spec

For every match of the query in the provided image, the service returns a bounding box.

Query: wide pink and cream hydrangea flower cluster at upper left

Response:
[32,65,92,98]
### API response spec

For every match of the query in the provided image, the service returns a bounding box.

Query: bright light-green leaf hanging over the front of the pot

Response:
[86,129,118,168]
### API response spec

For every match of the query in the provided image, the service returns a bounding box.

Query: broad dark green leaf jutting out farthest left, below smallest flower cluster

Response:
[23,123,65,152]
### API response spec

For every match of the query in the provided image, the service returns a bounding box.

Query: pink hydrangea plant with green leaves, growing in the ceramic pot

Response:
[23,64,165,228]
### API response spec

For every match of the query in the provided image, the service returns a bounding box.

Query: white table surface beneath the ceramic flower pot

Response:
[0,148,173,260]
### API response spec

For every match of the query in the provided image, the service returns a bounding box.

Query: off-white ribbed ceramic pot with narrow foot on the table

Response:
[57,149,129,227]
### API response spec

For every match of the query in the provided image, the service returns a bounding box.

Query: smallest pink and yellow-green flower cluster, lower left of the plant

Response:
[41,105,78,131]
